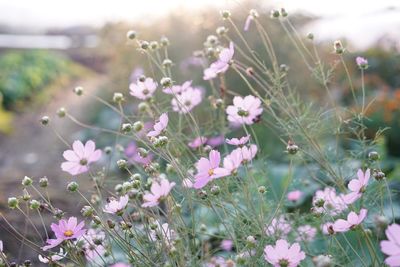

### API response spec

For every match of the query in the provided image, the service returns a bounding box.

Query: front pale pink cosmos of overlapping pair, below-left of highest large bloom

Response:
[171,87,202,114]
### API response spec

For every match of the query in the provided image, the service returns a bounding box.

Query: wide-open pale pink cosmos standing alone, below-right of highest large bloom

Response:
[226,95,263,125]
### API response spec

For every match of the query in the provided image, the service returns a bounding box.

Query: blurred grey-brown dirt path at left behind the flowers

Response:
[0,75,106,260]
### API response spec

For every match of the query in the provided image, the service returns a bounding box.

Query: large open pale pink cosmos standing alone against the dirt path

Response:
[61,140,101,175]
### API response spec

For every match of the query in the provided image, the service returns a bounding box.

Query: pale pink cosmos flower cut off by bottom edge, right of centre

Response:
[264,239,306,267]
